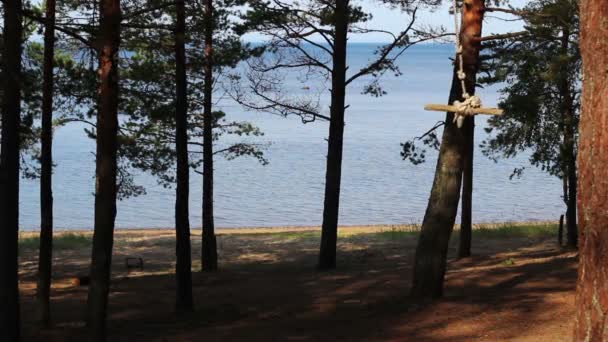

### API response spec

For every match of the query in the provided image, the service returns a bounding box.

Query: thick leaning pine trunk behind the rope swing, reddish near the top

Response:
[411,0,485,298]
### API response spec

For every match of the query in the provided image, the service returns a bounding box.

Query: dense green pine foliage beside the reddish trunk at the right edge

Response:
[480,0,581,178]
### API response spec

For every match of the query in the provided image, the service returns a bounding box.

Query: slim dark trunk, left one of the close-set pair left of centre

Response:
[175,0,193,312]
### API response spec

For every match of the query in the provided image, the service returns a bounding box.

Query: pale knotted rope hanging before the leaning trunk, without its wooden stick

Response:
[452,0,482,128]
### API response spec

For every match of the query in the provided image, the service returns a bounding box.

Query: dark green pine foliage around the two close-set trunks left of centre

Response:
[114,0,267,187]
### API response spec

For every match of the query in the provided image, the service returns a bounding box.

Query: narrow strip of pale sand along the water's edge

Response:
[19,221,558,237]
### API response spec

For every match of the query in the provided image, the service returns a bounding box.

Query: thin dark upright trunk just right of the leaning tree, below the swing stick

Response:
[458,117,475,258]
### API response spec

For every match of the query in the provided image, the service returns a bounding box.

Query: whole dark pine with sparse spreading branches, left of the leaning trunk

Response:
[235,0,442,270]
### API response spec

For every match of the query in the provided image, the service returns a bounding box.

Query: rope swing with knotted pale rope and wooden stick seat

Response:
[424,0,503,128]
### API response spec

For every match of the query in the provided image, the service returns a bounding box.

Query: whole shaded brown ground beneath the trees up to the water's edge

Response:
[20,224,577,342]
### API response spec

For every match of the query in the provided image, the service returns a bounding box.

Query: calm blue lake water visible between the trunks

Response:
[21,44,565,230]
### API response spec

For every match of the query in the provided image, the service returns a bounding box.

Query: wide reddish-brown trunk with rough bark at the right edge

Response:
[574,0,608,342]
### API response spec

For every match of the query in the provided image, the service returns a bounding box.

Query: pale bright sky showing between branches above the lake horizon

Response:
[245,0,527,43]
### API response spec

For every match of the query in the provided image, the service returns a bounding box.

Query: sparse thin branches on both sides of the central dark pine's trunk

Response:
[238,0,445,123]
